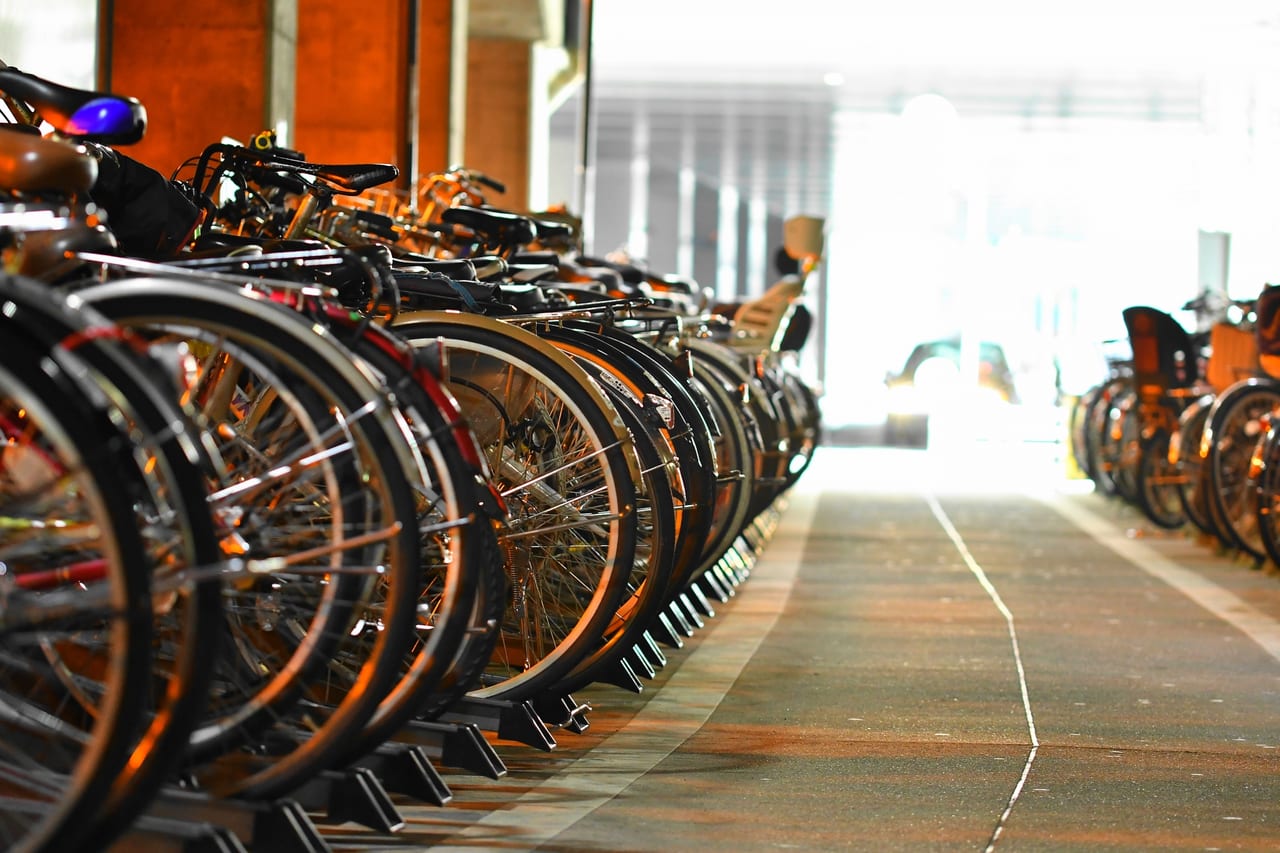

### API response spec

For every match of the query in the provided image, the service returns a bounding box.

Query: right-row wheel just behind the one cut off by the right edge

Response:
[1204,379,1280,561]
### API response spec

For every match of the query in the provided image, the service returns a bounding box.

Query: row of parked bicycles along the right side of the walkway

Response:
[1071,275,1280,566]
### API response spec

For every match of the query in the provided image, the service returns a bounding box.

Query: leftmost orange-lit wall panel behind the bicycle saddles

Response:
[100,0,284,175]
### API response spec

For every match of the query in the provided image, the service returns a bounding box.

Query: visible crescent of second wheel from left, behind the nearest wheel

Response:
[4,279,223,838]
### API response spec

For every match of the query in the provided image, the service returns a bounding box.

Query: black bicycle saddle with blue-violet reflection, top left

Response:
[0,67,147,145]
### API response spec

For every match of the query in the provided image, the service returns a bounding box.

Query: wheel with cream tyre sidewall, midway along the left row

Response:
[392,311,640,699]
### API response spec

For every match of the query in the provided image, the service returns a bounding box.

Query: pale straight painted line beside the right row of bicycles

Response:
[1039,497,1280,661]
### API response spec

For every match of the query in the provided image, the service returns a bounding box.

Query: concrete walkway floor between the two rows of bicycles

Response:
[323,443,1280,852]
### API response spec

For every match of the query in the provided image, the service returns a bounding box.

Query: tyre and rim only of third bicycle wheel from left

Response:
[79,278,419,798]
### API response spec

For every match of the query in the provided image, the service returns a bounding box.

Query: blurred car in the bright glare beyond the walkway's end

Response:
[884,337,1018,447]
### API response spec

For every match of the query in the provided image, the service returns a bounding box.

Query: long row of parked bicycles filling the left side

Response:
[0,68,822,850]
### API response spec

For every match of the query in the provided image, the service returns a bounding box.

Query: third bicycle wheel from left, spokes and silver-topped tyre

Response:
[81,279,420,798]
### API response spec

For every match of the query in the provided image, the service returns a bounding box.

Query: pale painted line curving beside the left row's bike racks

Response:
[431,491,818,853]
